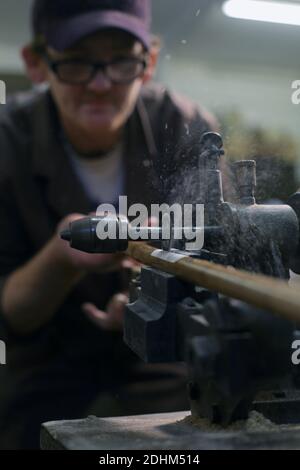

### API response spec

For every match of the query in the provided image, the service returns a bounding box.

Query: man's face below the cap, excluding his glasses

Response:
[43,30,149,134]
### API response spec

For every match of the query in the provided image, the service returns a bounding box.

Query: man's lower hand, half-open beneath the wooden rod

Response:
[82,293,129,331]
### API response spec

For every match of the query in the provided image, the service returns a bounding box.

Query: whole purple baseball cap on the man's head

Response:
[32,0,151,51]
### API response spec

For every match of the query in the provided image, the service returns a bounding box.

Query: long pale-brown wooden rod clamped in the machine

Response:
[127,242,300,324]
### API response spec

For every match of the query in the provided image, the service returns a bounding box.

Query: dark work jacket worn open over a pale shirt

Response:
[0,82,213,414]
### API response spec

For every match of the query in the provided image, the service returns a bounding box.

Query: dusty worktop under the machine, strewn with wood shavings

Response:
[41,411,300,450]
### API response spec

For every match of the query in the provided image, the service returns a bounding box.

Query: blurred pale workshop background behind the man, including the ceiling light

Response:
[0,0,300,201]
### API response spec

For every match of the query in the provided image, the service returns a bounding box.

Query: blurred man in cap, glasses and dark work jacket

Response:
[0,0,217,448]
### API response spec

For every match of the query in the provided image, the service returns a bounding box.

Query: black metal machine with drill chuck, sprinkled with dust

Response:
[62,133,300,425]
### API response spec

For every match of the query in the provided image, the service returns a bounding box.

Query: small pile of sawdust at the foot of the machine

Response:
[180,411,280,433]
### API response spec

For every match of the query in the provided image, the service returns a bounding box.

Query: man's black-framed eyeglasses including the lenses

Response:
[44,55,148,85]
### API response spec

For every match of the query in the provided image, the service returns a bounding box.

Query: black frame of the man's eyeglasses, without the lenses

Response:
[43,53,149,85]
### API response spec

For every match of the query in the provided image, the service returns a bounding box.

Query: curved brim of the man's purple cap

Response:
[45,10,150,51]
